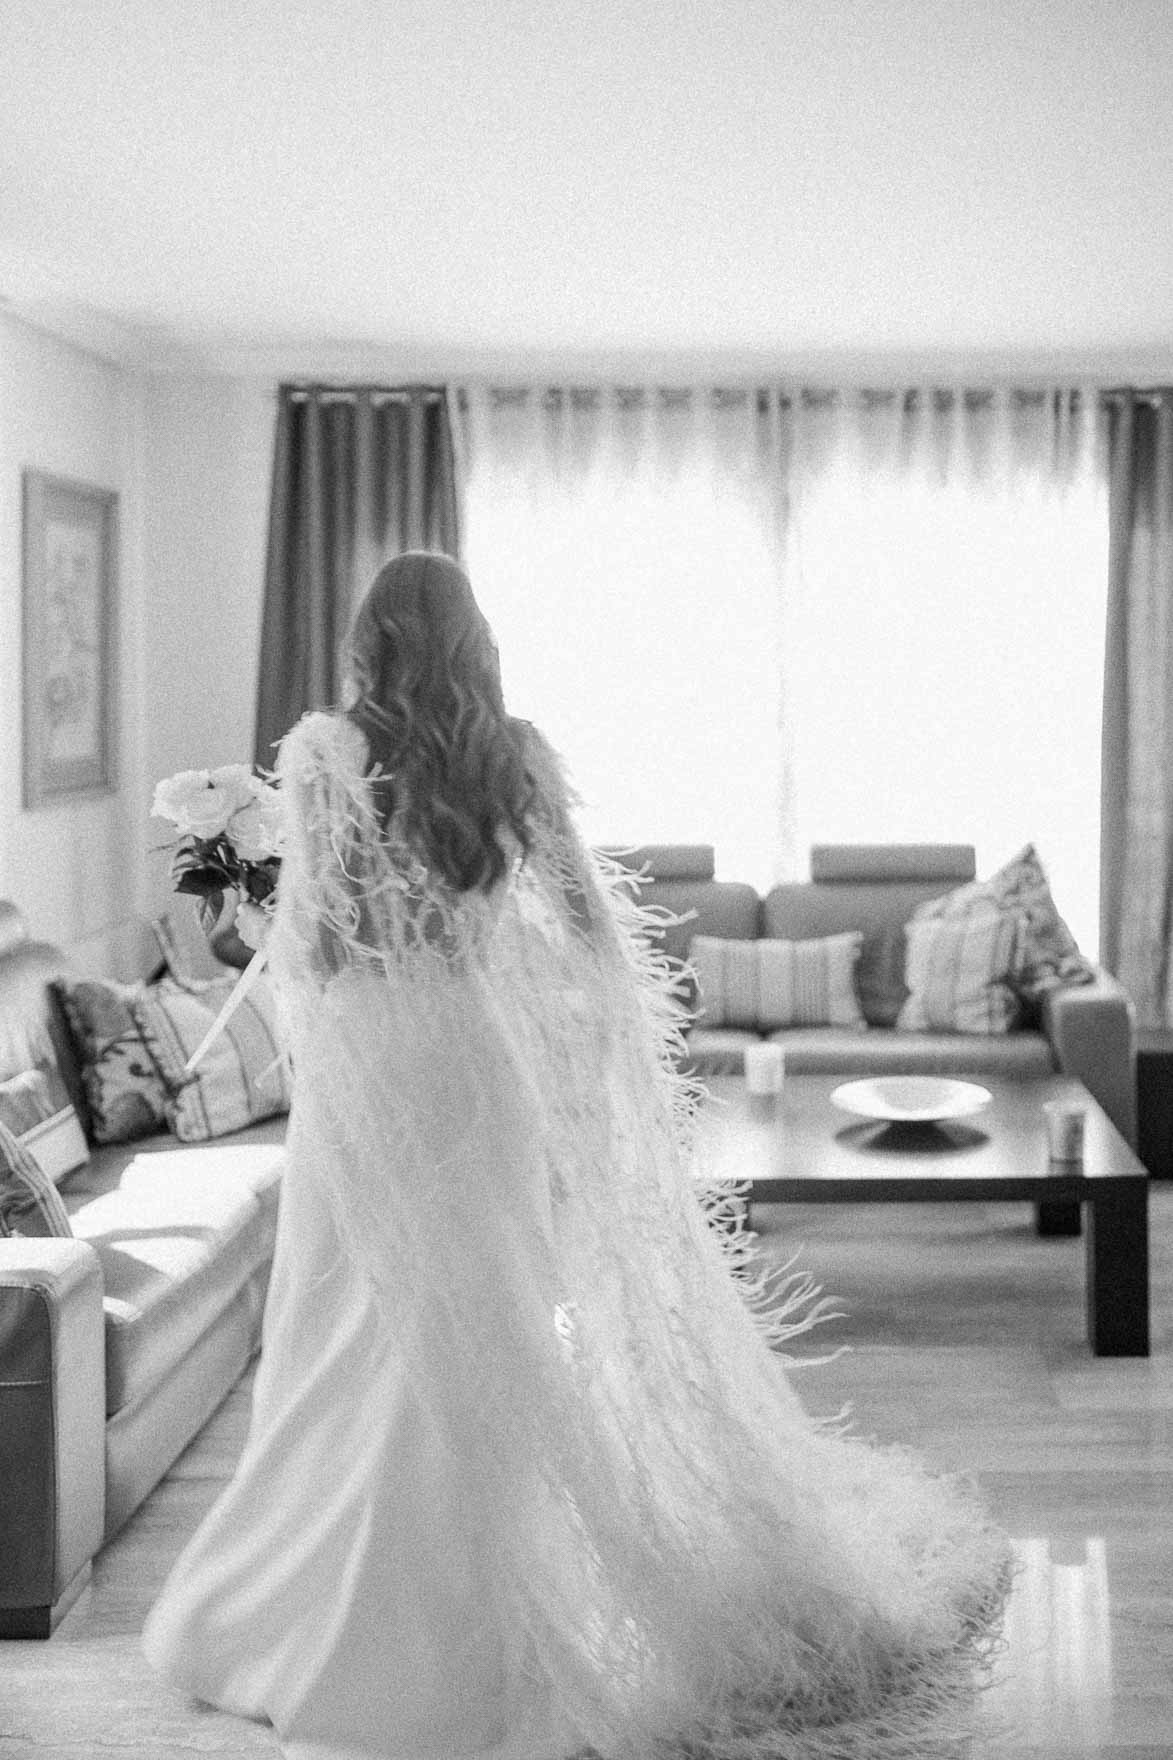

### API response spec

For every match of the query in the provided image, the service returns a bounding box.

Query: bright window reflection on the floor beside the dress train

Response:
[990,1538,1113,1753]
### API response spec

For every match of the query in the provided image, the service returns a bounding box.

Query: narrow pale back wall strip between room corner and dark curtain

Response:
[143,375,277,910]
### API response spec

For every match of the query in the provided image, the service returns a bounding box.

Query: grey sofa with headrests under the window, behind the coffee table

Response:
[608,843,1136,1146]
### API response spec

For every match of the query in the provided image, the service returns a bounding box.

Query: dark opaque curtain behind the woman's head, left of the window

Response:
[255,385,460,766]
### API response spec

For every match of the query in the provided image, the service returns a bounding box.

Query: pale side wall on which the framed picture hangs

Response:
[0,302,144,964]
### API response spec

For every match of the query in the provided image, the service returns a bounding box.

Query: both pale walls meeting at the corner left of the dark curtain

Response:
[0,330,275,975]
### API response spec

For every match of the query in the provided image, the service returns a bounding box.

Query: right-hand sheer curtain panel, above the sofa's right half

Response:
[780,387,1108,956]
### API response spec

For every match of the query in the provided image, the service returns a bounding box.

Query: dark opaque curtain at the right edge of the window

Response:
[1101,389,1173,1026]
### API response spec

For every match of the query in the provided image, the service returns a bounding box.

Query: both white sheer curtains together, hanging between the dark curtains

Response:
[461,385,1106,952]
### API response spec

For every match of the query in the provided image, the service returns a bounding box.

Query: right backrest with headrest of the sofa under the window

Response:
[761,843,976,1026]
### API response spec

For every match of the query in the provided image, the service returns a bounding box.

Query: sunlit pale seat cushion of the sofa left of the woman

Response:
[62,1119,285,1415]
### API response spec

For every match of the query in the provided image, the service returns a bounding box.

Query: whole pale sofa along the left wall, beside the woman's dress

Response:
[0,901,285,1637]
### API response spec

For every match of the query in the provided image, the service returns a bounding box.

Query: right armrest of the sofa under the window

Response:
[1041,966,1136,1149]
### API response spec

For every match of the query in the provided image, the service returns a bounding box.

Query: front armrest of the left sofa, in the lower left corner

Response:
[0,1237,106,1637]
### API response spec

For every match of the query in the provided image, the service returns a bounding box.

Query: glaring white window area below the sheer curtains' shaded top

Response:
[468,454,1106,954]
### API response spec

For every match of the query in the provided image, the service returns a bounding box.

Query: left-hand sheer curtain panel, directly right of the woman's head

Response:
[460,385,793,885]
